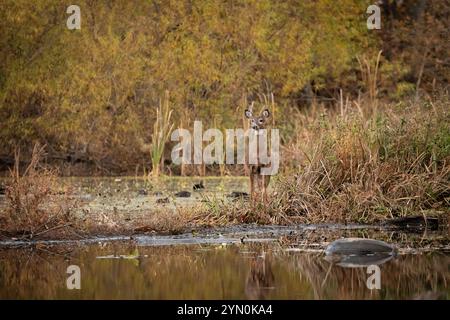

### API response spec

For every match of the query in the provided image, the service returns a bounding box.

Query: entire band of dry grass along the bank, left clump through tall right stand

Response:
[0,95,450,238]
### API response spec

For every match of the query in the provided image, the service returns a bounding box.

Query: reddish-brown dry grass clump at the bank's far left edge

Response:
[0,145,77,238]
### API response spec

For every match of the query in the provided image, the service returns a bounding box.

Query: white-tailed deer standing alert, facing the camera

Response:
[245,103,270,203]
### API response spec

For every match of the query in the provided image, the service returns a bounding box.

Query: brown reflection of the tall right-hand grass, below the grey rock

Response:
[286,253,450,299]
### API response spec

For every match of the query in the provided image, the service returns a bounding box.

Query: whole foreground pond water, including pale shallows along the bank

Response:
[0,225,450,299]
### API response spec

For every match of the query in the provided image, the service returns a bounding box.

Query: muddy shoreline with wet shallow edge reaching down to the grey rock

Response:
[0,224,450,253]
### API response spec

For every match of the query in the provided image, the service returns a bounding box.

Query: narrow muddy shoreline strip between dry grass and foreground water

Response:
[0,223,450,246]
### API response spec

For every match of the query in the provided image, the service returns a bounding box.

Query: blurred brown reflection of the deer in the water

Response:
[245,251,275,300]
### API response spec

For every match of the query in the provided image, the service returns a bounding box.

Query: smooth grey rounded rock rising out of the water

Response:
[325,238,397,268]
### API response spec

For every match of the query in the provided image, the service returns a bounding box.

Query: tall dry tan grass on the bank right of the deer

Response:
[196,95,450,224]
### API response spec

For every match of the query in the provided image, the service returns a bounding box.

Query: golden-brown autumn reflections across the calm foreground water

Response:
[0,243,450,299]
